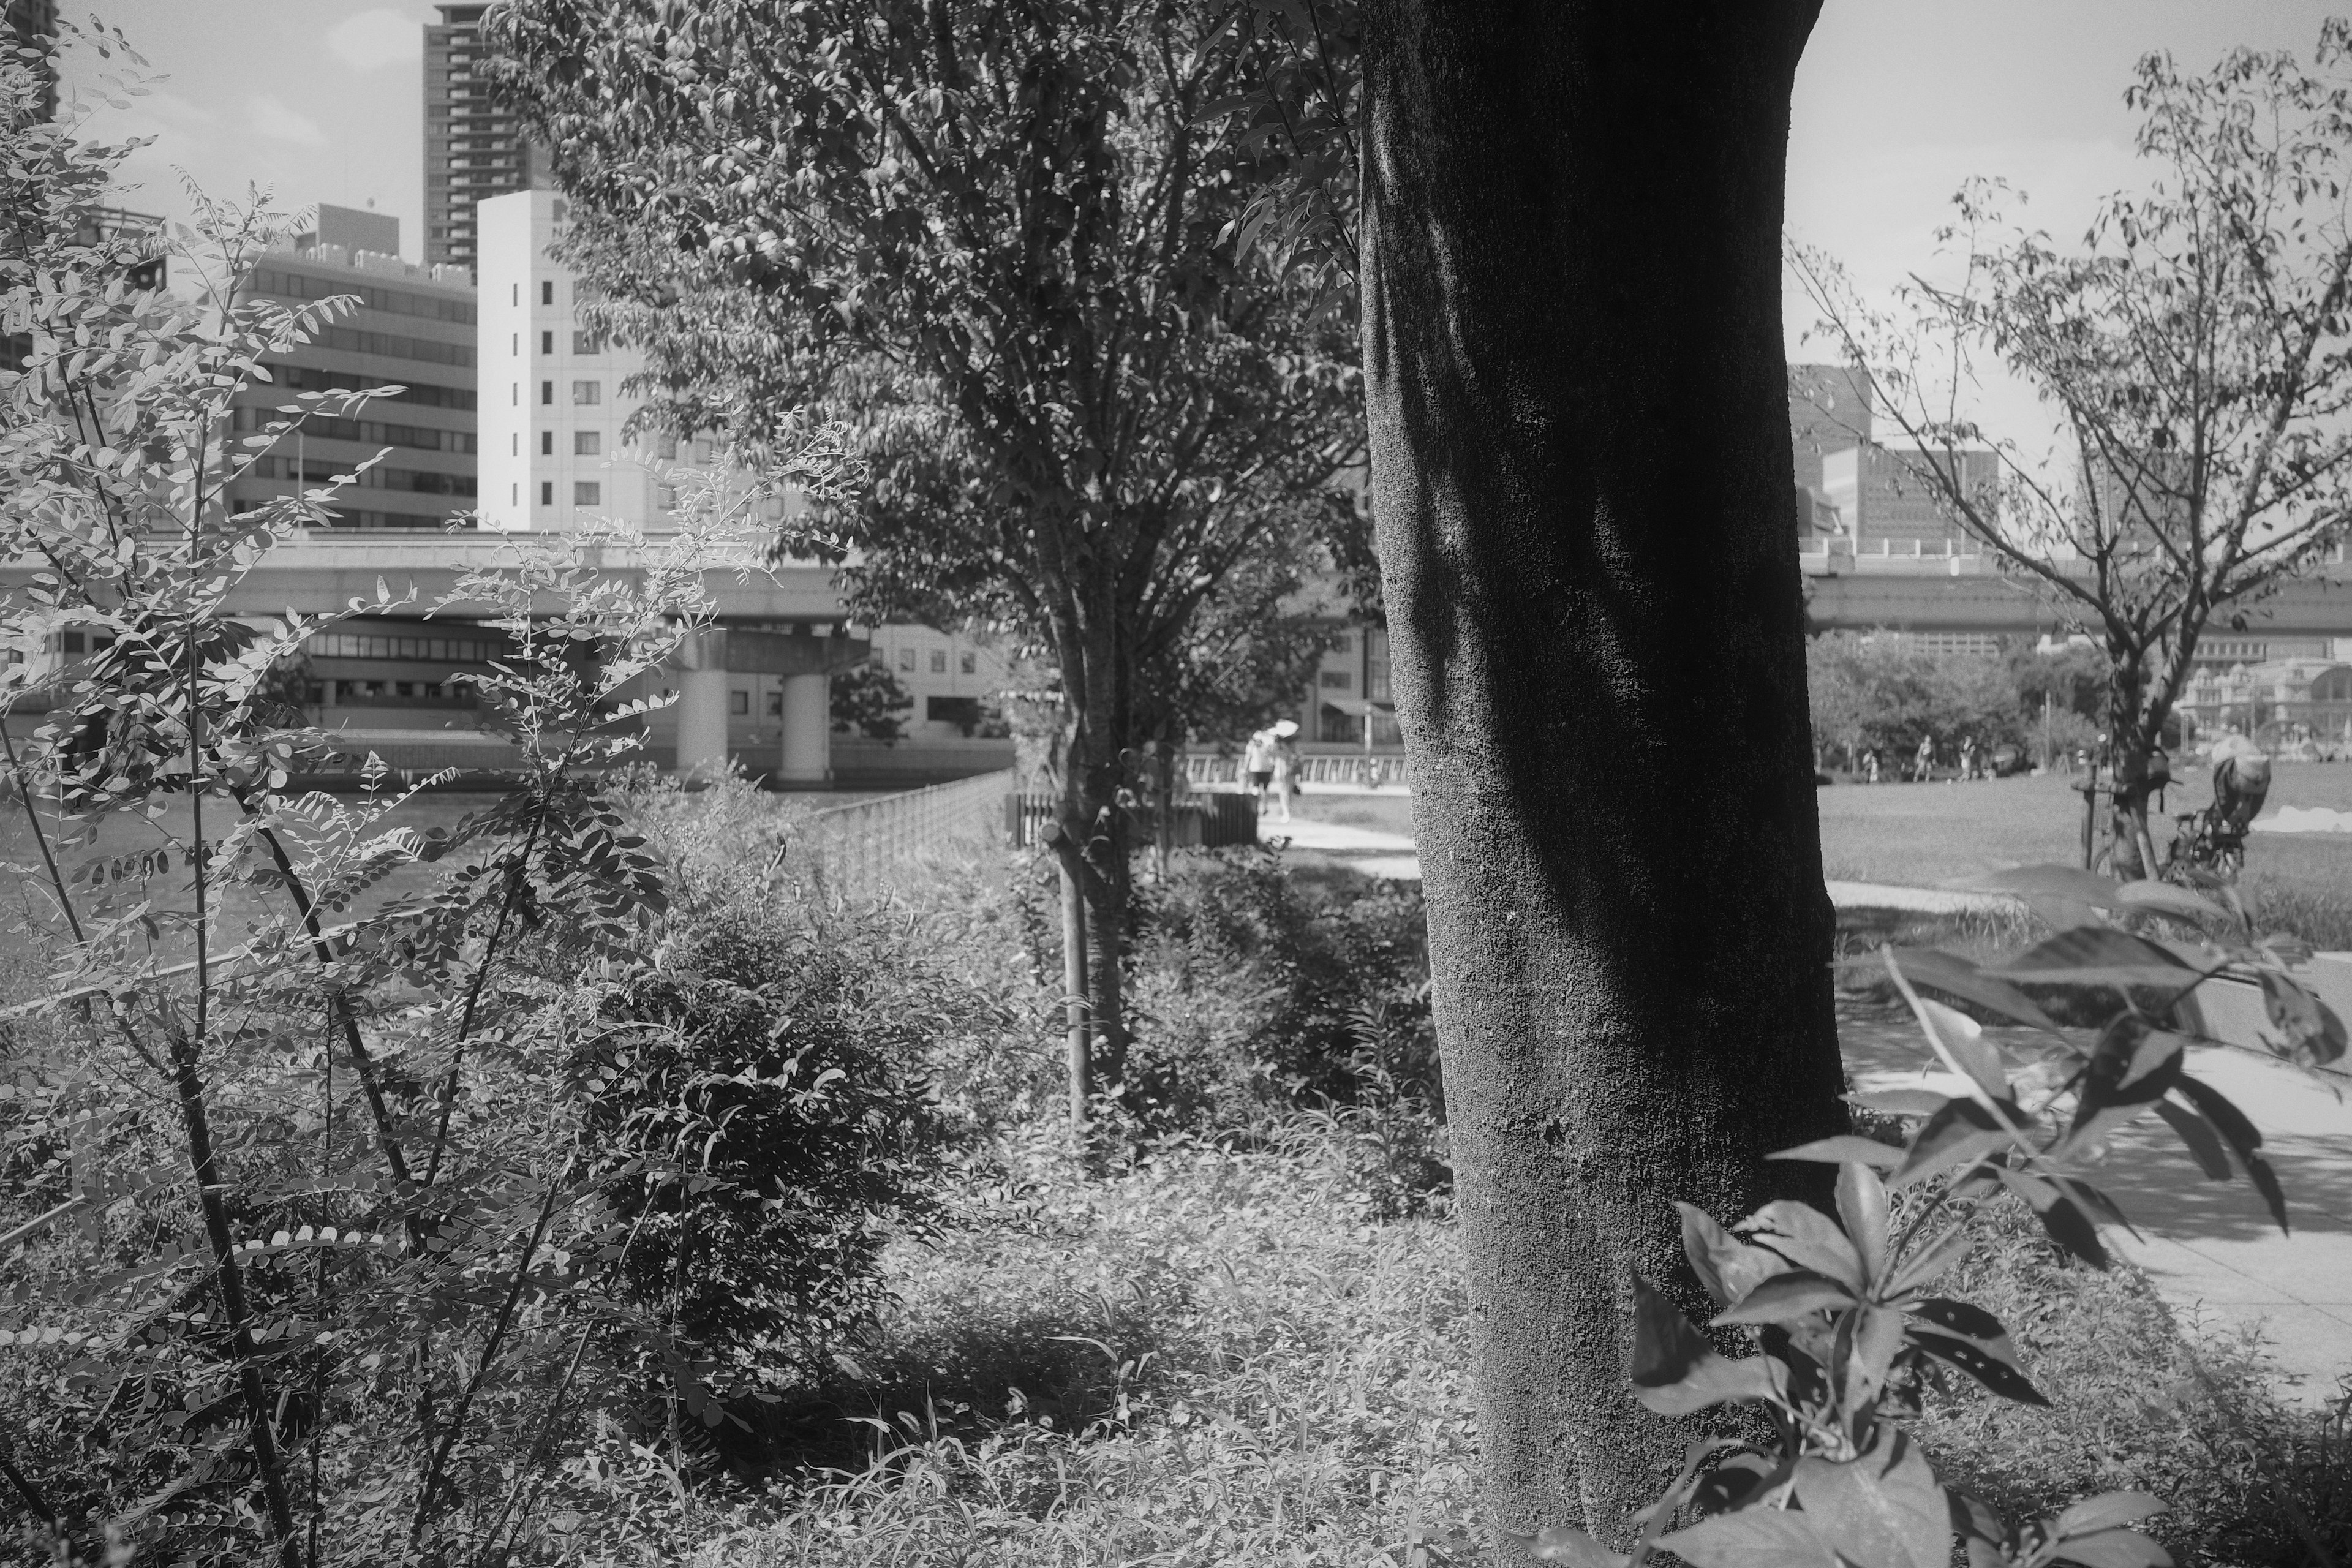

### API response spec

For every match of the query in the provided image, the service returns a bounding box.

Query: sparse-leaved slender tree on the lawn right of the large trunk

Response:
[1792,21,2352,877]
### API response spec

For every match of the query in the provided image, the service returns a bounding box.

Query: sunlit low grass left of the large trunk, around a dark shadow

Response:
[687,1140,1475,1568]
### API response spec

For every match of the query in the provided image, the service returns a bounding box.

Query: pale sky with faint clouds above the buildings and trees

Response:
[64,0,2352,435]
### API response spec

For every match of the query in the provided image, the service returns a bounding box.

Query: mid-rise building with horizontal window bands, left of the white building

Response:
[228,207,478,529]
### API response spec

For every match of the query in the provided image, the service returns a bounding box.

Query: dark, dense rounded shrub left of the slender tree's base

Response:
[581,884,946,1425]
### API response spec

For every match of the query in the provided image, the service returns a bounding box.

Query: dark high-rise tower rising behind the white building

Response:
[426,5,543,270]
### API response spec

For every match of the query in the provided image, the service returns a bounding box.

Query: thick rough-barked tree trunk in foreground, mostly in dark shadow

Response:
[1364,0,1844,1537]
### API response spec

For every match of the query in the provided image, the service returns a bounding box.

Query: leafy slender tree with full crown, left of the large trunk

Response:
[489,0,1362,1082]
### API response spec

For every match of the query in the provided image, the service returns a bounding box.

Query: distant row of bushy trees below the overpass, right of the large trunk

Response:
[1804,632,2109,769]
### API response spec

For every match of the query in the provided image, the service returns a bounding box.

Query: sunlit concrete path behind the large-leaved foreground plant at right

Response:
[1839,1004,2352,1408]
